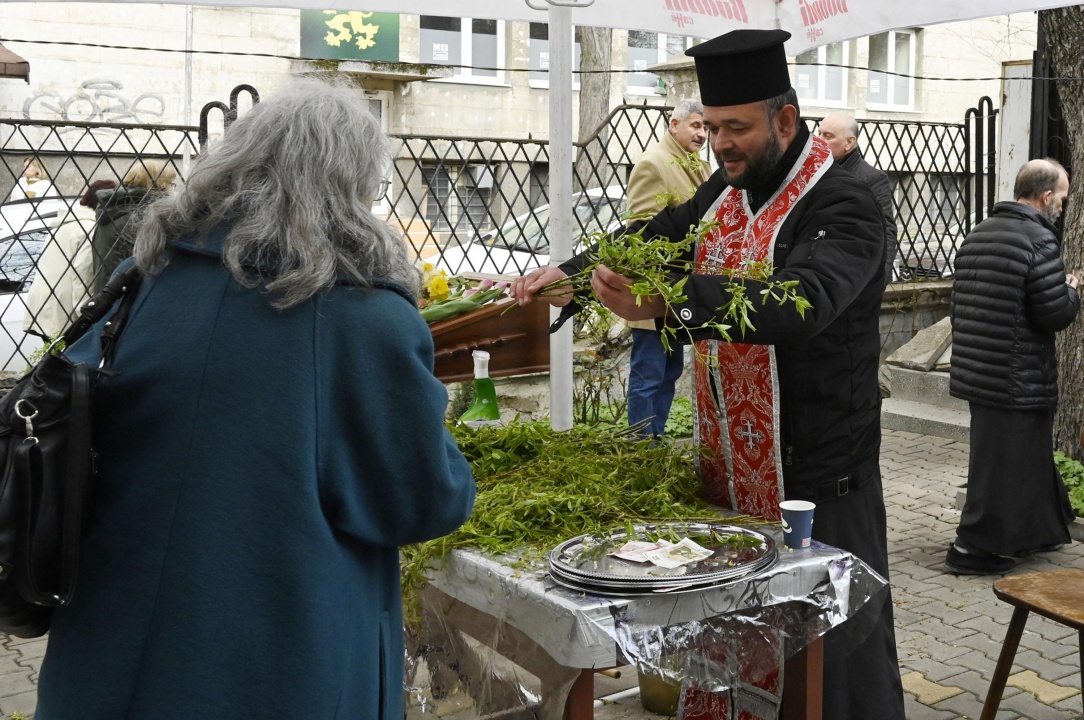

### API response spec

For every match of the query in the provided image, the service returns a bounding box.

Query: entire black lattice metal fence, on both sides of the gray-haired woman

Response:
[0,93,995,372]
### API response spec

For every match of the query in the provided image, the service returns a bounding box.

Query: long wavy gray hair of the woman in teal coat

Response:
[132,79,420,309]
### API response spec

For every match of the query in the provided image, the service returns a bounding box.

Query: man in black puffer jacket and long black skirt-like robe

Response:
[945,159,1080,575]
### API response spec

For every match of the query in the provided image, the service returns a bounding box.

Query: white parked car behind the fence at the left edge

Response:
[0,197,79,372]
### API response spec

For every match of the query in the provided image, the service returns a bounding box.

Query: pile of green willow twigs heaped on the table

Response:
[402,422,751,613]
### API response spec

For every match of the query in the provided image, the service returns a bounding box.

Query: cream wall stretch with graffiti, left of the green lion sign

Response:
[0,2,299,125]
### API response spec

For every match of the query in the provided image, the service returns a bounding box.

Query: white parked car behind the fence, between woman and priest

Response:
[436,185,625,275]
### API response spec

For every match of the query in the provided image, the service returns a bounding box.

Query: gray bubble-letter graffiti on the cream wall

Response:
[23,78,166,125]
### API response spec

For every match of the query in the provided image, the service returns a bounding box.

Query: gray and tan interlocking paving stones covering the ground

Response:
[0,430,1084,720]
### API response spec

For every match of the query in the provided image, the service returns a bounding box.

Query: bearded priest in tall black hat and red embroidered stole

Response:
[512,30,904,720]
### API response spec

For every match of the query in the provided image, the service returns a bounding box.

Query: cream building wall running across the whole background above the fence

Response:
[0,7,1036,138]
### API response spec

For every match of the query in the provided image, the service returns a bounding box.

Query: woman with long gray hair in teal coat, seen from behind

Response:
[35,80,475,720]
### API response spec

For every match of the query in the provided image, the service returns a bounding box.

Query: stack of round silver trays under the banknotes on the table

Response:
[549,523,777,595]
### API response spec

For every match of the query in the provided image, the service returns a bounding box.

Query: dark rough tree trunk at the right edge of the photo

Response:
[1038,5,1084,458]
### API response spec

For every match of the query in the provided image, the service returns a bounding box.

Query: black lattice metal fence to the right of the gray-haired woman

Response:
[389,98,996,280]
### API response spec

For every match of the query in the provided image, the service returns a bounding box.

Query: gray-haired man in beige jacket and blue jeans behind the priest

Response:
[628,100,711,435]
